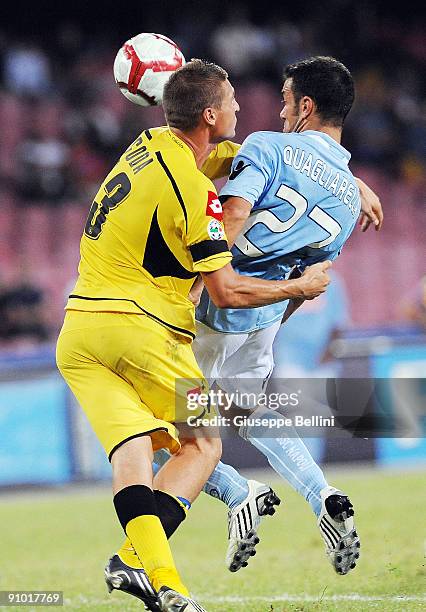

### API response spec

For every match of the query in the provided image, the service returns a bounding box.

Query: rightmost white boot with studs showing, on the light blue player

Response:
[318,487,361,575]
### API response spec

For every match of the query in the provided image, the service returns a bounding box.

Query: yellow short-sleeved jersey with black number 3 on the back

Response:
[66,127,238,339]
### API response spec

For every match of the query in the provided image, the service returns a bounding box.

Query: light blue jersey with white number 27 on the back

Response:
[197,130,360,334]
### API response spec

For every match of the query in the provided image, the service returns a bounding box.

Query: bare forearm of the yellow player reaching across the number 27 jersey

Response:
[201,261,331,308]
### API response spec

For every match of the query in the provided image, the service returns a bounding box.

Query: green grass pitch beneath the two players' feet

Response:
[0,470,426,612]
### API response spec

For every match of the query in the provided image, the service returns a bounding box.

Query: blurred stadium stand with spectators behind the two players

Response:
[0,0,426,484]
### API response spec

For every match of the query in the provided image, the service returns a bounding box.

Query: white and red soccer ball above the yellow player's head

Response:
[114,33,185,106]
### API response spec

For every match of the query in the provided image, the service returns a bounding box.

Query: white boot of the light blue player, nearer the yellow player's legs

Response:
[225,480,281,572]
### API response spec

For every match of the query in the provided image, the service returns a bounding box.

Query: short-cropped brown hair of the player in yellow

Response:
[163,59,228,130]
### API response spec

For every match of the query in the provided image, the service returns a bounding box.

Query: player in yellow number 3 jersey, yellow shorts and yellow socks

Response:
[57,60,330,612]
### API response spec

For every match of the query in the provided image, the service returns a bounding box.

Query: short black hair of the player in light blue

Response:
[284,56,355,126]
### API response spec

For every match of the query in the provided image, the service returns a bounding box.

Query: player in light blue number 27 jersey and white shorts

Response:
[190,57,372,574]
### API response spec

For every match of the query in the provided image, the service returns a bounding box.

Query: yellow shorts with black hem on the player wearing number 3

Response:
[56,310,207,459]
